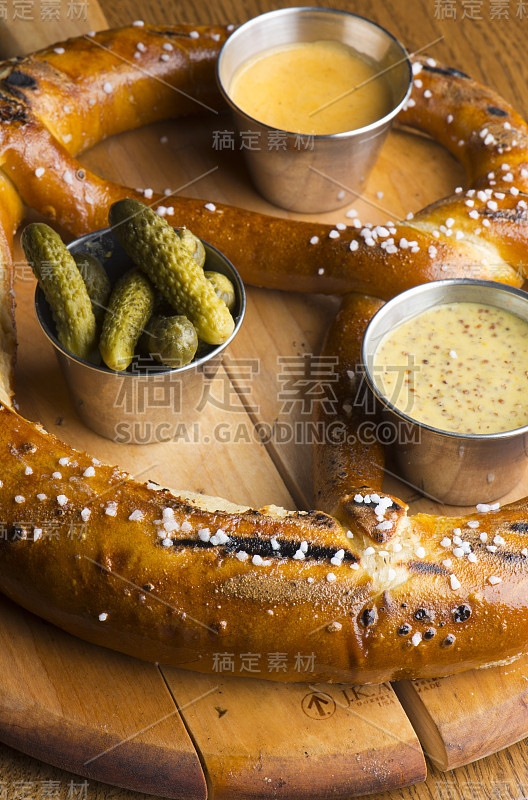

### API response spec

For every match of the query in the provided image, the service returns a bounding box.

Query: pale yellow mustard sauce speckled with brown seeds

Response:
[373,303,528,434]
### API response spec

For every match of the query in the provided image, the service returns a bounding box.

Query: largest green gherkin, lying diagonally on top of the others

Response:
[109,199,235,344]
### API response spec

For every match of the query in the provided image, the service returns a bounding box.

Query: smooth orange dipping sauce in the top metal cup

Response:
[229,41,392,134]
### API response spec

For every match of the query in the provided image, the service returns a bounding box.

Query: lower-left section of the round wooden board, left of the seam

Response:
[0,598,206,800]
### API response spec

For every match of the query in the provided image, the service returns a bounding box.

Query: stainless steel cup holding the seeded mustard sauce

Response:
[362,279,528,505]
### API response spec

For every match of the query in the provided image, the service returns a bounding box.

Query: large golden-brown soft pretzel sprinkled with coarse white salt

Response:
[0,25,528,682]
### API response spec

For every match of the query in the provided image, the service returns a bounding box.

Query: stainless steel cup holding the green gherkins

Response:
[32,200,246,444]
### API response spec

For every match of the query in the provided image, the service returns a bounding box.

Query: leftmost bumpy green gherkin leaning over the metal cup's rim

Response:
[22,222,97,361]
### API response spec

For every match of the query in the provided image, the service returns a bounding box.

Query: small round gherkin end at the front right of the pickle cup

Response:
[139,315,198,369]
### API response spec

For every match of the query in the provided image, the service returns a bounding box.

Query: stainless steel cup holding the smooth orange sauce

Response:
[217,7,412,212]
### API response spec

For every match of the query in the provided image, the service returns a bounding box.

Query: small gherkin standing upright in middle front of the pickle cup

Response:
[99,269,154,372]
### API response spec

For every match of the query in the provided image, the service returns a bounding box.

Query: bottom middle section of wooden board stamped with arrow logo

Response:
[163,665,425,800]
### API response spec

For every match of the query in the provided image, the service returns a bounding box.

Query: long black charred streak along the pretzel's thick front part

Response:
[172,535,358,563]
